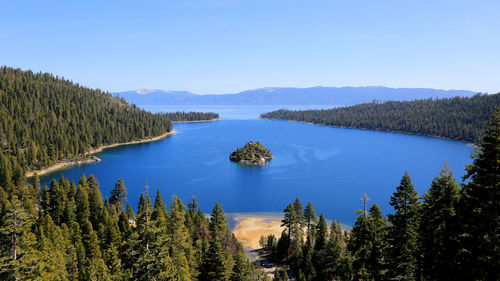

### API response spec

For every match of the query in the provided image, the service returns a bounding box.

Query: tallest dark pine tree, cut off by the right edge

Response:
[458,108,500,280]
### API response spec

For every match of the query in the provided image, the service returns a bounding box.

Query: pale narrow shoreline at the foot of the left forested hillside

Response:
[25,130,178,178]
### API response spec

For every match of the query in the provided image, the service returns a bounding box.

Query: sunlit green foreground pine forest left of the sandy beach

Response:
[0,175,260,281]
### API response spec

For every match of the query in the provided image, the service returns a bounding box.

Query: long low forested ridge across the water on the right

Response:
[261,94,500,144]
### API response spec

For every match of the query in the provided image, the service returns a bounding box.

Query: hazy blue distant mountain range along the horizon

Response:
[114,87,476,105]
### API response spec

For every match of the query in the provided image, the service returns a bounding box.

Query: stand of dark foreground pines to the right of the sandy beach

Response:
[260,108,500,281]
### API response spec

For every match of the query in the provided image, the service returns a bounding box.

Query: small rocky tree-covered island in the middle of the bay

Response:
[229,141,273,166]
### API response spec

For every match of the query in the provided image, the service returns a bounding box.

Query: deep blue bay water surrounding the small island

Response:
[41,105,473,225]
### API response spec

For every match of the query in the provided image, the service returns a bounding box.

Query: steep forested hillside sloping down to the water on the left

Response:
[0,67,172,173]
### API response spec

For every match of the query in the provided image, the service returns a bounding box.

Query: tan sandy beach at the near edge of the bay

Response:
[233,214,284,250]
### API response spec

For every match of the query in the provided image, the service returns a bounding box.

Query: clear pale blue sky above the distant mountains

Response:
[0,0,500,93]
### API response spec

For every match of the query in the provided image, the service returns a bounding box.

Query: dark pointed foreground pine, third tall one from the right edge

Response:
[388,172,420,280]
